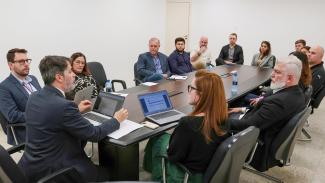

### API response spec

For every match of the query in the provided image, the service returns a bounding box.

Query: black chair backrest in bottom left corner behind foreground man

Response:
[0,145,27,183]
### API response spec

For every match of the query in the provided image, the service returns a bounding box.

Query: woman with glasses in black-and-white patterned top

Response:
[67,52,98,100]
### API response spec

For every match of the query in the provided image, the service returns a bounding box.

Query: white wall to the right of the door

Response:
[191,0,325,65]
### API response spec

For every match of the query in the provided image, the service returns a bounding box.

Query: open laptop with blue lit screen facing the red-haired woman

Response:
[138,90,185,125]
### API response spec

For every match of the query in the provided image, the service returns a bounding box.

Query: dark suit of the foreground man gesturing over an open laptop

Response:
[18,86,120,182]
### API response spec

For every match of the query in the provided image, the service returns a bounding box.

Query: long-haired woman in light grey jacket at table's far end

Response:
[251,41,275,68]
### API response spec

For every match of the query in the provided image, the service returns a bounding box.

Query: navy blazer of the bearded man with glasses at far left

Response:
[0,74,41,145]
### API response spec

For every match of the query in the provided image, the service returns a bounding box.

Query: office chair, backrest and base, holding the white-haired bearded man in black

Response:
[243,107,311,183]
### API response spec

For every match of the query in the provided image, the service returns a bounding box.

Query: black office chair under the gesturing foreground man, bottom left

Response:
[0,144,80,183]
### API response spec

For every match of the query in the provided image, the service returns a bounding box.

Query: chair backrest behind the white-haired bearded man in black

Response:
[271,106,311,164]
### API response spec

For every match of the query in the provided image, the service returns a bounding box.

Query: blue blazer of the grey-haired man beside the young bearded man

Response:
[137,52,170,81]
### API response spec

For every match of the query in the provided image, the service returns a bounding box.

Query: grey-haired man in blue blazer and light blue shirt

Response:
[136,38,170,82]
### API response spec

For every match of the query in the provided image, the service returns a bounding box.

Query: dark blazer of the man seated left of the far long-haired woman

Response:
[216,44,244,65]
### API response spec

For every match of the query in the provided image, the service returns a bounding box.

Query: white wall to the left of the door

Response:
[0,0,166,87]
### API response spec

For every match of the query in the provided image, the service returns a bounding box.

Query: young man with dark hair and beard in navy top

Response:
[167,37,193,75]
